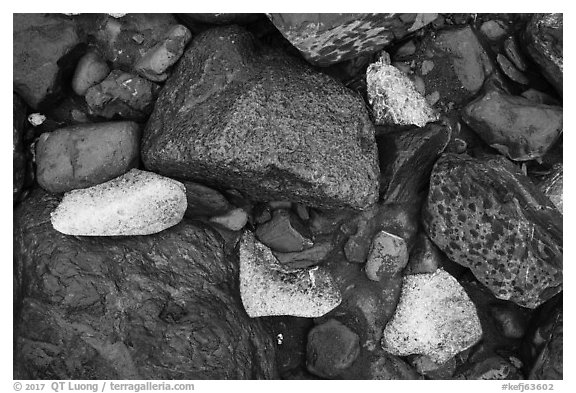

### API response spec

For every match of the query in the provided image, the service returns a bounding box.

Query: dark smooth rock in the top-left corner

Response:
[13,14,80,109]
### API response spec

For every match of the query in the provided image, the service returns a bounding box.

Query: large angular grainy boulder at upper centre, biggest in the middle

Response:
[142,26,379,209]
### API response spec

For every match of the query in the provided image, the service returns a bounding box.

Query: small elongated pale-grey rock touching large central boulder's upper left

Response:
[134,25,192,82]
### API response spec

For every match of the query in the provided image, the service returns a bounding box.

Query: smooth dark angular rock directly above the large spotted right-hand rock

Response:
[462,89,563,161]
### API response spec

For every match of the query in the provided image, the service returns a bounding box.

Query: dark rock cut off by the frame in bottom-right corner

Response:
[529,306,564,379]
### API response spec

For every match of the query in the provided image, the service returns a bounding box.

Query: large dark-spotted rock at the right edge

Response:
[423,154,562,308]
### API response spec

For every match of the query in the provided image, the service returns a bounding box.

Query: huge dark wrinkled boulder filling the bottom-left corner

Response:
[14,189,275,380]
